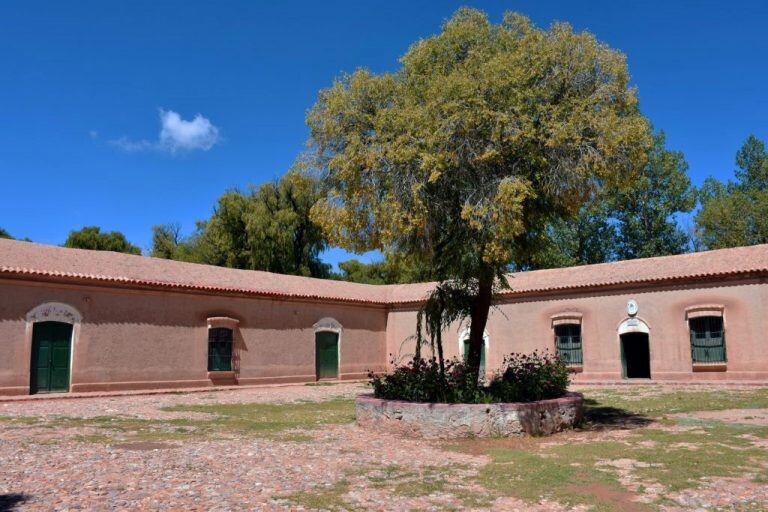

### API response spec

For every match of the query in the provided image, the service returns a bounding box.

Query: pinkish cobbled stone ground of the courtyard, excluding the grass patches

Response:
[0,384,768,511]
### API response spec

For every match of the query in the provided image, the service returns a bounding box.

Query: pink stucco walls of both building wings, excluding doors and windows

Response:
[0,272,768,394]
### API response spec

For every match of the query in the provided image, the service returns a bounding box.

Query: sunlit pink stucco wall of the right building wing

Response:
[387,280,768,381]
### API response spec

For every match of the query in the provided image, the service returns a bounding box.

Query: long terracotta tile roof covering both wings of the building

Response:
[0,239,768,304]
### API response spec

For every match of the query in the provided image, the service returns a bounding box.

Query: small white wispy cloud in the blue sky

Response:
[110,109,221,154]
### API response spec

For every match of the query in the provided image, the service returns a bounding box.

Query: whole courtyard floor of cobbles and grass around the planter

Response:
[0,383,768,511]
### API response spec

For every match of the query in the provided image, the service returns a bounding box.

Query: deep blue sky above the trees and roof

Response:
[0,0,768,263]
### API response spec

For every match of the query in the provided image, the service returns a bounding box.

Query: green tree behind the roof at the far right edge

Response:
[696,135,768,249]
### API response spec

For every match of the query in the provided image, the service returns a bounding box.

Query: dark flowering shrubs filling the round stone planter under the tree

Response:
[369,352,569,403]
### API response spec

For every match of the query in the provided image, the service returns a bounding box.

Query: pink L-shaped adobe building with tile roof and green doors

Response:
[0,240,768,395]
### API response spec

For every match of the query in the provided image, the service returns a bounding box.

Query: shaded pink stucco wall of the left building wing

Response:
[0,281,386,394]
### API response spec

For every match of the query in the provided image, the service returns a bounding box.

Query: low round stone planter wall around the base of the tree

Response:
[355,393,583,439]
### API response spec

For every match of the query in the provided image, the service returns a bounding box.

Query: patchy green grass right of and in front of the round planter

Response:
[449,389,768,510]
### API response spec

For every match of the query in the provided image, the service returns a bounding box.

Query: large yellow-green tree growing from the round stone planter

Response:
[307,8,650,372]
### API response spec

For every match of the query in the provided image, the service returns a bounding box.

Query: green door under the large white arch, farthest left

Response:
[30,322,72,393]
